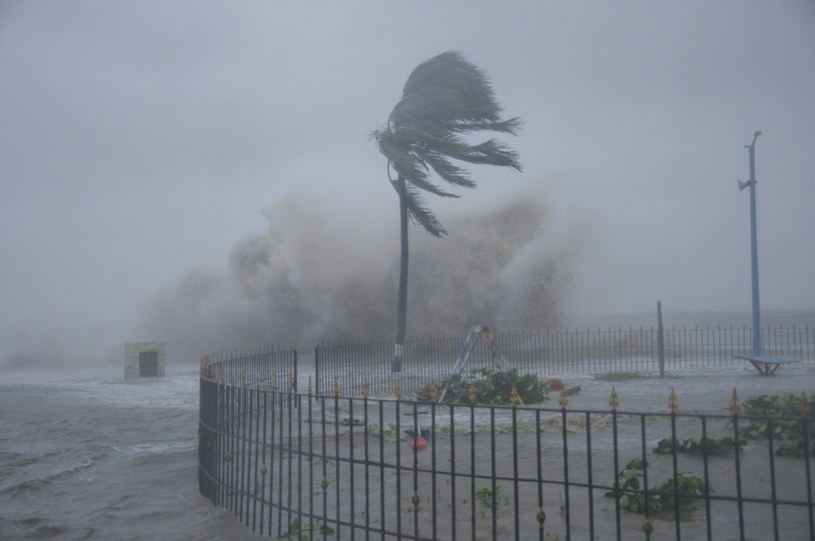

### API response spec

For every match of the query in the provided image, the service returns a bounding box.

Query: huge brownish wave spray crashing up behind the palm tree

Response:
[131,190,585,360]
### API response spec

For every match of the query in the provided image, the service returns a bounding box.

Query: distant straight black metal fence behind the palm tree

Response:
[314,326,815,395]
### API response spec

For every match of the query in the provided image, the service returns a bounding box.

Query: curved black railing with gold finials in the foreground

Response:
[199,340,815,540]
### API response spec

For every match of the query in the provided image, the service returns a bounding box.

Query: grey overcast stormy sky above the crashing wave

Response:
[0,0,815,354]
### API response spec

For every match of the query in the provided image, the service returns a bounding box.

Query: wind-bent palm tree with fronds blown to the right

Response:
[373,51,521,372]
